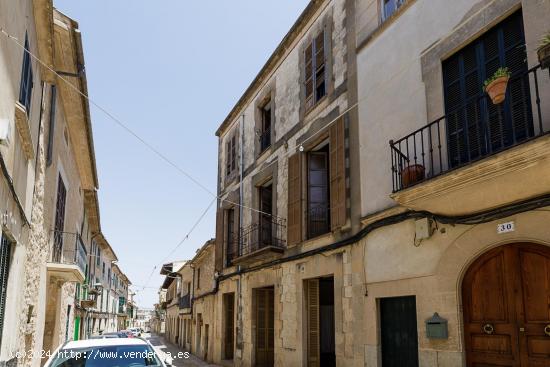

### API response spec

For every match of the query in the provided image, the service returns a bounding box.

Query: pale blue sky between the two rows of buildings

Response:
[54,0,308,307]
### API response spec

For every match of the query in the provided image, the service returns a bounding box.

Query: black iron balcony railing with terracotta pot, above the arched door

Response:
[390,65,550,192]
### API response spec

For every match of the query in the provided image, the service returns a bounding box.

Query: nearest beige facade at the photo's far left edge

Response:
[0,0,52,363]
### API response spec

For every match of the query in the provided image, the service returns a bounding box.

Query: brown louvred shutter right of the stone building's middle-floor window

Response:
[330,118,347,230]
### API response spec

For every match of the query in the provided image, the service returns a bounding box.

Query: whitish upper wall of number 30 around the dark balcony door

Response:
[356,0,550,215]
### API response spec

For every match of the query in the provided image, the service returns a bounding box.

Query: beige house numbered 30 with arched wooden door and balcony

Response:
[356,0,550,366]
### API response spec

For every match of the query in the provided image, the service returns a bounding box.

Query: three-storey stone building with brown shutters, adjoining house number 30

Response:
[211,0,367,366]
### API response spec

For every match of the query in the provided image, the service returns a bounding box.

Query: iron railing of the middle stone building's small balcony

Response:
[239,216,286,256]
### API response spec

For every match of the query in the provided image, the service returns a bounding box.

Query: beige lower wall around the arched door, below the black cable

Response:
[360,208,550,366]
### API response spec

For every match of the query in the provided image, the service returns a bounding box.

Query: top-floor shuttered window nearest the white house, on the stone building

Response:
[304,29,327,111]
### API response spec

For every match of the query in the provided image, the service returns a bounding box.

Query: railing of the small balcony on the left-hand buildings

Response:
[50,231,88,274]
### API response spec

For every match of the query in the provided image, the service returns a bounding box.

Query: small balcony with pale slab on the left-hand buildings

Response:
[46,231,88,283]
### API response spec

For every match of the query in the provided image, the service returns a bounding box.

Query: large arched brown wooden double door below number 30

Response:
[462,243,550,367]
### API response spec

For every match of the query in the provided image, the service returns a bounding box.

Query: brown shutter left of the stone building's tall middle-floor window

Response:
[287,153,302,245]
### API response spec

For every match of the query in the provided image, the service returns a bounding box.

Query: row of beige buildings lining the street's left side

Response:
[0,0,132,366]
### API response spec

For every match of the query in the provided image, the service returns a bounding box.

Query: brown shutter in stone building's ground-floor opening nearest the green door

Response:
[306,279,321,367]
